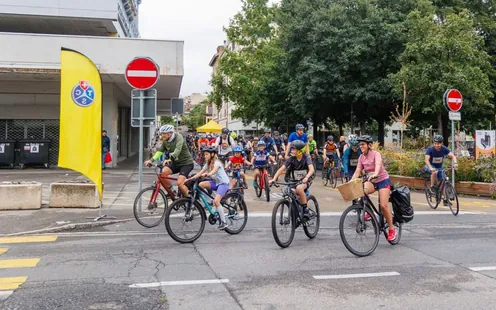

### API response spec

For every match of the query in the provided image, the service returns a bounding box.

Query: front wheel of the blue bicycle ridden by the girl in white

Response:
[164,198,206,243]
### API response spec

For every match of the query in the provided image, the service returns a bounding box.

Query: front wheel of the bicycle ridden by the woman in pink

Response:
[339,205,379,257]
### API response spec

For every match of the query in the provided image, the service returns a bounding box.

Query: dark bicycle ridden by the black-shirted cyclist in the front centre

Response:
[272,181,320,248]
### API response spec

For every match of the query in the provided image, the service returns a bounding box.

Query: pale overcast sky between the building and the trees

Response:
[139,0,241,96]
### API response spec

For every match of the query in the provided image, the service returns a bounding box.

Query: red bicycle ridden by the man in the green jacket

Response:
[133,164,183,228]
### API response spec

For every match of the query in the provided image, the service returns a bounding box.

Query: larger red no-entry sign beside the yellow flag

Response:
[126,57,160,89]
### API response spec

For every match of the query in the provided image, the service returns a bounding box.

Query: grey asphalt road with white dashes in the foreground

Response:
[0,212,496,310]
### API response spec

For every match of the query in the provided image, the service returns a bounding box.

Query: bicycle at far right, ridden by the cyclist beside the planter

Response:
[424,167,460,216]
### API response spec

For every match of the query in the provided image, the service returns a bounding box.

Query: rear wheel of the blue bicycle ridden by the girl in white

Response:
[222,193,248,235]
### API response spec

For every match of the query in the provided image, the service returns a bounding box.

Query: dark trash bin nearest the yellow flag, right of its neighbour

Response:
[17,139,50,169]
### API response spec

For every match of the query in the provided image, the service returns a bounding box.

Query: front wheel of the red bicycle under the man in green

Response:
[133,186,169,228]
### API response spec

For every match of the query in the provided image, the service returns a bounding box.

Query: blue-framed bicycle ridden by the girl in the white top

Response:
[164,178,248,243]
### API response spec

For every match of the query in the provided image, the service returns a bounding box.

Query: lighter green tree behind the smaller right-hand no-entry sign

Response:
[391,6,494,143]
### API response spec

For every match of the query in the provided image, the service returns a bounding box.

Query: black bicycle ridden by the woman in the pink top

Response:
[339,179,402,257]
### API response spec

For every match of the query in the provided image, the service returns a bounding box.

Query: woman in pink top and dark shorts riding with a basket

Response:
[351,136,396,241]
